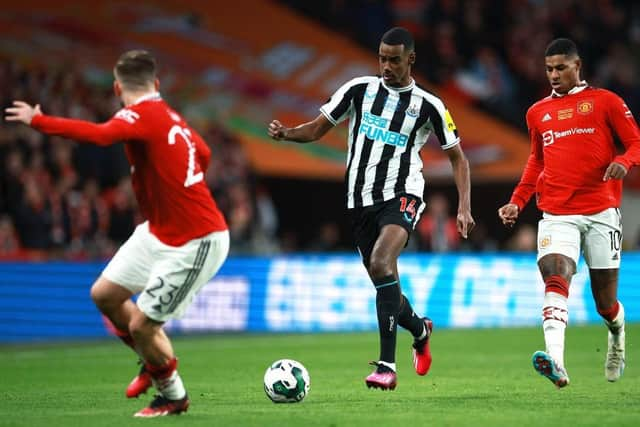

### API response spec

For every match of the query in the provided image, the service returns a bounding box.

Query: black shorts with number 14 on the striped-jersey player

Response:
[349,194,424,267]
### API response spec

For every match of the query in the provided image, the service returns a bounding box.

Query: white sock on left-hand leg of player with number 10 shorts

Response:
[542,292,569,366]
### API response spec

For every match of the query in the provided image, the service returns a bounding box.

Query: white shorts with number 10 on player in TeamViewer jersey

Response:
[538,208,622,269]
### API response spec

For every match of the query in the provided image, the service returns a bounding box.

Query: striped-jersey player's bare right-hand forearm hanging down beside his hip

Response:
[445,144,476,239]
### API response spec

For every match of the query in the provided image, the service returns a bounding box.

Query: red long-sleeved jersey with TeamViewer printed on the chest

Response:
[511,86,640,215]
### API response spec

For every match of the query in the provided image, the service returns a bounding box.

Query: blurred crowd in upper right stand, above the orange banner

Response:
[281,0,640,129]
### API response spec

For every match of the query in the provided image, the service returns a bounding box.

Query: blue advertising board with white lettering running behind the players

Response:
[0,253,640,343]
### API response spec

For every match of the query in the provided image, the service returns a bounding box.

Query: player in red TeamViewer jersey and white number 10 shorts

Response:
[498,38,640,387]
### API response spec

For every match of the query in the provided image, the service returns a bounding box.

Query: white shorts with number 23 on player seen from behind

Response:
[102,221,229,322]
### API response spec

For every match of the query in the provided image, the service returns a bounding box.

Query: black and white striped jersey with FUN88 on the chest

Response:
[320,76,460,208]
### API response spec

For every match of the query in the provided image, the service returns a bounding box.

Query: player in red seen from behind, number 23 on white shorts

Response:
[6,50,229,417]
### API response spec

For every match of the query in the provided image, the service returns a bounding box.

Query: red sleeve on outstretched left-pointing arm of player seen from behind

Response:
[31,108,141,145]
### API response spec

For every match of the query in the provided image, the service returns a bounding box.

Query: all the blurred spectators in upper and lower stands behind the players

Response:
[0,0,640,260]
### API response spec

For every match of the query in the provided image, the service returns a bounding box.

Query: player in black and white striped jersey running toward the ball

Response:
[268,27,474,390]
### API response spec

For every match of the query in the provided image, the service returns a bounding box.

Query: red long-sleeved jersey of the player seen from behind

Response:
[31,94,227,246]
